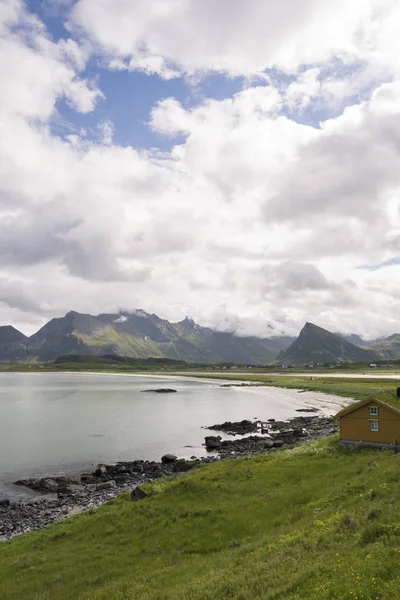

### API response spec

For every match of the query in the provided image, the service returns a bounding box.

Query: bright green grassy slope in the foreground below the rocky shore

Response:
[0,436,400,600]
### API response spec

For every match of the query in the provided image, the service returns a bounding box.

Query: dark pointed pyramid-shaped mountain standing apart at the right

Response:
[276,323,378,366]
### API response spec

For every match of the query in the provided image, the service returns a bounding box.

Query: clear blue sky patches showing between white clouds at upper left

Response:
[27,0,245,150]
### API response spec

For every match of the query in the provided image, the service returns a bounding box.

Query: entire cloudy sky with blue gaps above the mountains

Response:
[0,0,400,339]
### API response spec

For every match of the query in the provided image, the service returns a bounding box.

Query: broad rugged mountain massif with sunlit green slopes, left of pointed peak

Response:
[0,310,292,365]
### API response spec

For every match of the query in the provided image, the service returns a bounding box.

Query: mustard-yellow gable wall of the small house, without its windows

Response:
[340,401,400,444]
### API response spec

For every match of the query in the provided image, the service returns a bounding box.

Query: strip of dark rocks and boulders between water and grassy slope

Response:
[0,416,337,541]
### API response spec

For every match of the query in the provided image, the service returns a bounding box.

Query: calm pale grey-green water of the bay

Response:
[0,373,342,498]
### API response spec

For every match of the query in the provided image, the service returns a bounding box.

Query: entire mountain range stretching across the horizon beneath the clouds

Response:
[0,310,400,366]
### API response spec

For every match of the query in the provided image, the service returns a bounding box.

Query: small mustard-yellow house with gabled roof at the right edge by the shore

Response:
[336,398,400,446]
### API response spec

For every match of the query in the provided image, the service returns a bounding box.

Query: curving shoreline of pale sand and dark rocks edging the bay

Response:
[0,378,352,541]
